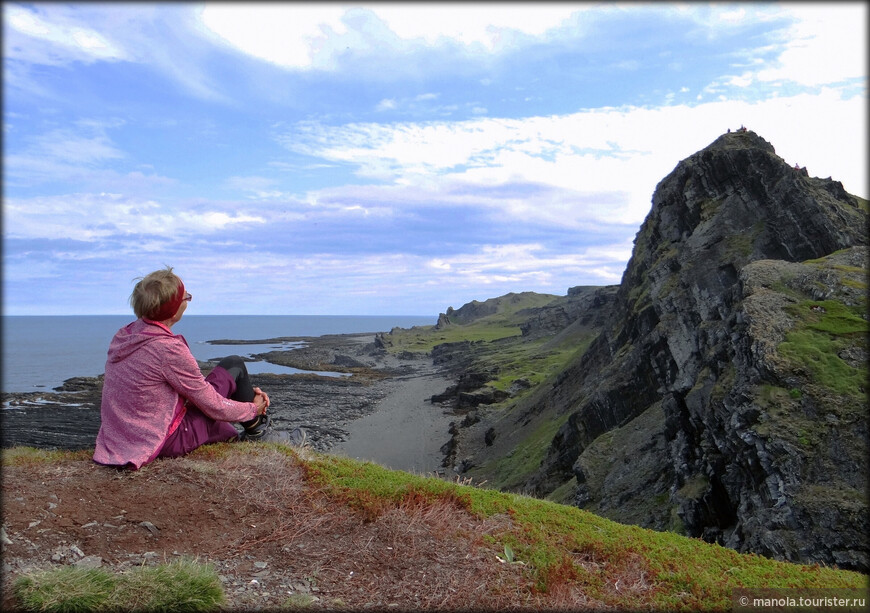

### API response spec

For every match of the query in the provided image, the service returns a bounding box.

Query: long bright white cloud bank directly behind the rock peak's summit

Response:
[278,90,867,226]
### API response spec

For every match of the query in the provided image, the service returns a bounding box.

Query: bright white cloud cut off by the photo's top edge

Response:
[199,3,588,70]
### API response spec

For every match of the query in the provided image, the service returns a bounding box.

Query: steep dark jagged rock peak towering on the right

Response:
[526,131,870,572]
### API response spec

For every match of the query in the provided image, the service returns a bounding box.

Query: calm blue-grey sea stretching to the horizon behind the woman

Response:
[0,315,438,392]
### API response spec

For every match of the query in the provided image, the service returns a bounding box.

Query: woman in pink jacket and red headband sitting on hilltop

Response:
[94,267,304,470]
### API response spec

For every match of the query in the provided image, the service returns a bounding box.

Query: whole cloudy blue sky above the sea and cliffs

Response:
[3,2,868,317]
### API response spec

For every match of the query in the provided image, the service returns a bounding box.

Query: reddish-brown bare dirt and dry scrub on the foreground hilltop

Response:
[2,443,594,611]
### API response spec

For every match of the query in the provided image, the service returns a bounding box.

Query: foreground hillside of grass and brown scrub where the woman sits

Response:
[3,444,867,611]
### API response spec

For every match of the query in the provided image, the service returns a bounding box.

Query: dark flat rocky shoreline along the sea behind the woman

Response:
[2,333,460,466]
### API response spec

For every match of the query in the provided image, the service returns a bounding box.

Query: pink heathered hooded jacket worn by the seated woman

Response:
[94,319,257,469]
